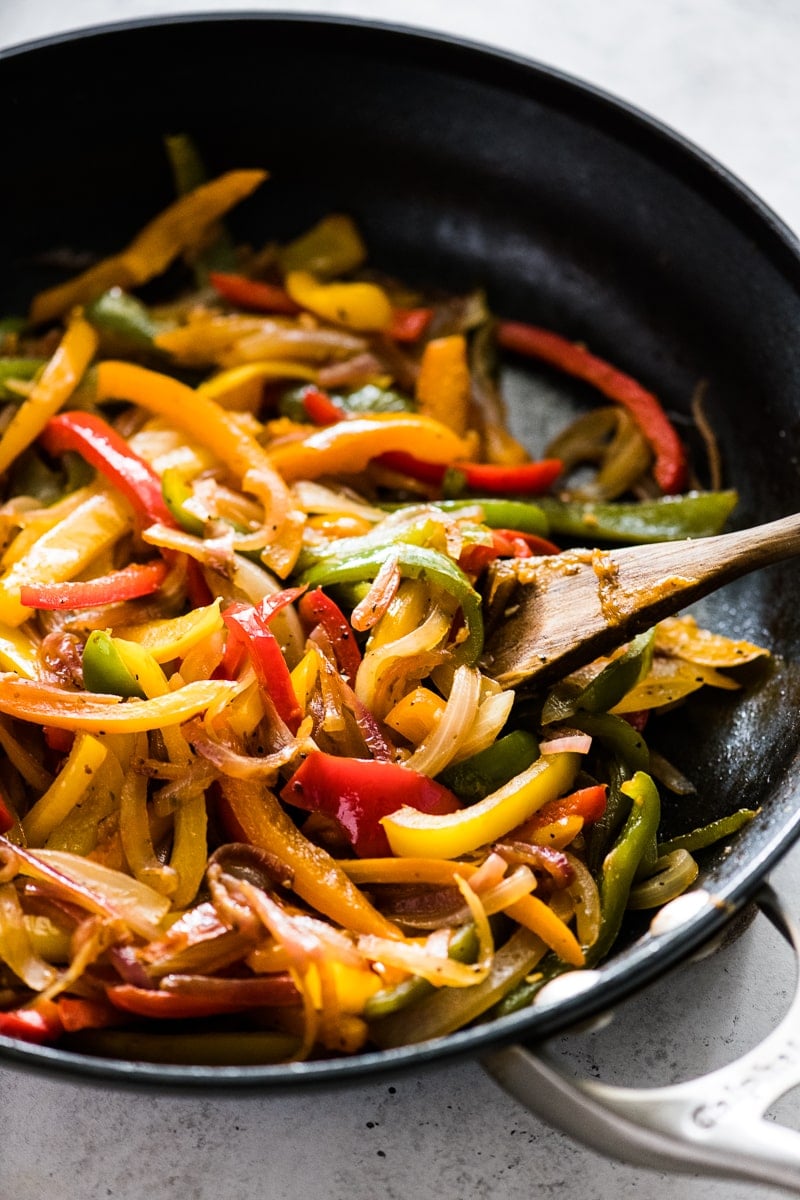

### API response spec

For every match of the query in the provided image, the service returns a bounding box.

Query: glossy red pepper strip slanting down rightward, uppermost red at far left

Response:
[41,412,175,527]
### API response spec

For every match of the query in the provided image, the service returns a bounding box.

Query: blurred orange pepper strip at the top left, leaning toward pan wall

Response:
[30,170,267,325]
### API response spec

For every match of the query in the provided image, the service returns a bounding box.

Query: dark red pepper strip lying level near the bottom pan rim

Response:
[106,971,300,1020]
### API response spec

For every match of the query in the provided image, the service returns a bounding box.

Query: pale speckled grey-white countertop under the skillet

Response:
[0,0,800,1200]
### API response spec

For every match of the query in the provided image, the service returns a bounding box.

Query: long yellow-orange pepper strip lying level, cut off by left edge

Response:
[0,673,237,736]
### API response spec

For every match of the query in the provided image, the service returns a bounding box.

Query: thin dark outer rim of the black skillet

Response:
[0,11,800,1094]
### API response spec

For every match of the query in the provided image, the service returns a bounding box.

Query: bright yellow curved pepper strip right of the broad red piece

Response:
[381,752,581,858]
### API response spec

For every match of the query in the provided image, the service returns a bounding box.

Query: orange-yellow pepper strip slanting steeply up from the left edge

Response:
[0,317,97,472]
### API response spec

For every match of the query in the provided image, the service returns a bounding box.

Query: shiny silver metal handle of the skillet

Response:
[483,886,800,1195]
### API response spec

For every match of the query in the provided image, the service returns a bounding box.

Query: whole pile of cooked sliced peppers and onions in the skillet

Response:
[0,137,765,1063]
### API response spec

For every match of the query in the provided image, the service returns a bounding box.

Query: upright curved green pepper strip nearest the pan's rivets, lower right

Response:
[587,770,661,965]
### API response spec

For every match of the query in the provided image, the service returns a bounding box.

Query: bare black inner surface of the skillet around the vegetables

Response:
[0,14,800,1087]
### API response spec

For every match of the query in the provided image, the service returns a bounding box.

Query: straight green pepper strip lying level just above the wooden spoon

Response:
[537,491,739,544]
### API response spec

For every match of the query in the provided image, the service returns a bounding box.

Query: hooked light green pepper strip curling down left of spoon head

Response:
[300,541,483,665]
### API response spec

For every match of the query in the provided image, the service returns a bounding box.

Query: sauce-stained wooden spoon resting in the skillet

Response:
[482,514,800,688]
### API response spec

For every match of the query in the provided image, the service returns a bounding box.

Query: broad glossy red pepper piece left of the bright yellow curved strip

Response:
[281,750,462,858]
